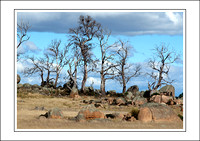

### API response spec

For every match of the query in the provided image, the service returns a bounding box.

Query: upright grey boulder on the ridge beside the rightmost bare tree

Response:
[159,85,175,99]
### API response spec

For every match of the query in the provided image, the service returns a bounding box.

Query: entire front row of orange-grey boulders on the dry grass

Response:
[39,103,181,122]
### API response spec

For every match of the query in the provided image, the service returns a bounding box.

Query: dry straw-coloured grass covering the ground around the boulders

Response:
[17,94,183,129]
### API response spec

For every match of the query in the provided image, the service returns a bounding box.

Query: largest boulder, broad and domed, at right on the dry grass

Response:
[138,103,180,122]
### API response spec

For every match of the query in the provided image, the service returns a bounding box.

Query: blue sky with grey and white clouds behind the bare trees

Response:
[17,11,183,96]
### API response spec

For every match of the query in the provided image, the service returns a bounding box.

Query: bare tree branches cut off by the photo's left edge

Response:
[17,19,31,48]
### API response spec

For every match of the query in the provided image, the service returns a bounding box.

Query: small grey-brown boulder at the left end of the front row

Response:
[39,108,63,119]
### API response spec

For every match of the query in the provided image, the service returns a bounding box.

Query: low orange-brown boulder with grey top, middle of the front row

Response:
[75,105,105,121]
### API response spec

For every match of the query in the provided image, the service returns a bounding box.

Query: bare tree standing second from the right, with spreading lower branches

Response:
[116,40,141,93]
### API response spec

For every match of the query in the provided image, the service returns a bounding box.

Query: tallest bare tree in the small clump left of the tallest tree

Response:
[48,40,68,88]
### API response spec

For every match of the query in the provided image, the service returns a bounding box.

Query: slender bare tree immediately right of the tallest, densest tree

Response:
[97,29,118,95]
